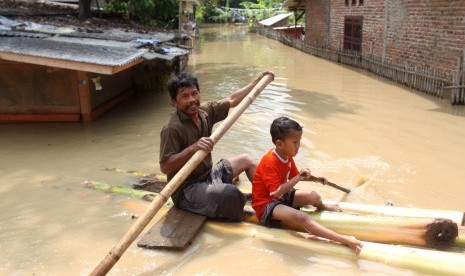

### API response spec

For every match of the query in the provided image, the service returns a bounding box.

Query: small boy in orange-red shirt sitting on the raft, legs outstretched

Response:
[252,117,362,254]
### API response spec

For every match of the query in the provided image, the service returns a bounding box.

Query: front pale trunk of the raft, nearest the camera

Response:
[84,181,465,275]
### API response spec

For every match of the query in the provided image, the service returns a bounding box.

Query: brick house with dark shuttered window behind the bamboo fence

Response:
[284,0,465,103]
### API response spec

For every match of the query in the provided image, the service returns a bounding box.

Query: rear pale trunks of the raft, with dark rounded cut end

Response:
[96,168,465,249]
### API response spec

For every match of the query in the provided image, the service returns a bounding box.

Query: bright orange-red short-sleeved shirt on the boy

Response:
[252,149,299,220]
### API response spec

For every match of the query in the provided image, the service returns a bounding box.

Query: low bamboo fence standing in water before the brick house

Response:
[251,28,465,105]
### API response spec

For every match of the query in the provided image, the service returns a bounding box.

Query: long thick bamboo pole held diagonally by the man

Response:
[90,74,273,275]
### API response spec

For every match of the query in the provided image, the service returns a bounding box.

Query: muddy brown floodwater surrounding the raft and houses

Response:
[0,24,465,275]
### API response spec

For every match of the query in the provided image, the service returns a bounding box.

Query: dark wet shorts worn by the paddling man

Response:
[177,159,246,221]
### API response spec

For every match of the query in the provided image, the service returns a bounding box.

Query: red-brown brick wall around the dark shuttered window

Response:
[306,0,465,76]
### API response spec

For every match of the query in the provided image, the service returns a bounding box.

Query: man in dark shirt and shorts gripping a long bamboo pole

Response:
[160,71,271,221]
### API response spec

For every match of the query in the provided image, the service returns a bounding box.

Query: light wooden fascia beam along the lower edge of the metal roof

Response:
[0,52,143,75]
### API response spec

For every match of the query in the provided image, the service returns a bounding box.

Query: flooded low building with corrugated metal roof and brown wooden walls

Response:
[0,17,189,122]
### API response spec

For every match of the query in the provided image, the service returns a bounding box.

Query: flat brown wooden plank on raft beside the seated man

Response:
[137,206,207,250]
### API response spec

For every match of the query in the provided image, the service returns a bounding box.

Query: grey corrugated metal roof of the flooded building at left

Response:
[0,17,189,74]
